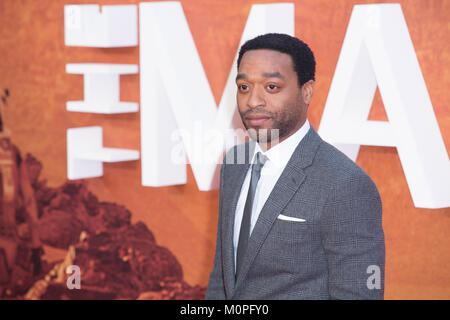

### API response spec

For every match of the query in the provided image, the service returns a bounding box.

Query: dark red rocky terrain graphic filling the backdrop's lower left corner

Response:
[0,145,205,299]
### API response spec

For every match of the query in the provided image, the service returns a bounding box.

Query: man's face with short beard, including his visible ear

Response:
[236,49,314,142]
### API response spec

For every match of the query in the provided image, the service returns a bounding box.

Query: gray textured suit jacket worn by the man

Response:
[206,127,385,299]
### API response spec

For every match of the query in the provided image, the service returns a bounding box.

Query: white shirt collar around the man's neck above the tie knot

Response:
[251,119,310,168]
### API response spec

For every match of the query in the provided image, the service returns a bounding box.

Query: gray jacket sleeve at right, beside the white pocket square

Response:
[320,171,385,299]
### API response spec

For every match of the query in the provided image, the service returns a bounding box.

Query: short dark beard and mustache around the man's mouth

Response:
[239,106,302,143]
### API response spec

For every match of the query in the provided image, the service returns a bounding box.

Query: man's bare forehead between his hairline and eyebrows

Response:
[238,49,295,75]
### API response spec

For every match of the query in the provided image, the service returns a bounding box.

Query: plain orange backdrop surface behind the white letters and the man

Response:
[0,0,450,299]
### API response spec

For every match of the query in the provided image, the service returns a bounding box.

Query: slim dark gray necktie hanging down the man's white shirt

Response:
[236,152,267,278]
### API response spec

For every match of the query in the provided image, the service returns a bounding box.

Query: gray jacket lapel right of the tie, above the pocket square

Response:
[231,126,322,292]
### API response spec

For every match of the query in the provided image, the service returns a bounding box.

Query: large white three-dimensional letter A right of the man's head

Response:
[319,4,450,209]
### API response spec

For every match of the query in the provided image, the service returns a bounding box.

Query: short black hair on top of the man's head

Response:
[237,33,316,86]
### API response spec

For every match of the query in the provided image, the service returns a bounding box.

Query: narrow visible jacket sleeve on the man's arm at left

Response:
[205,164,225,300]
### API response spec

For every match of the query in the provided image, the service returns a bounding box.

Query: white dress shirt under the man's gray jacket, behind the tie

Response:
[233,120,310,271]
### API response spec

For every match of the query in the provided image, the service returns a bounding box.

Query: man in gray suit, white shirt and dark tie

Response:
[206,34,385,299]
